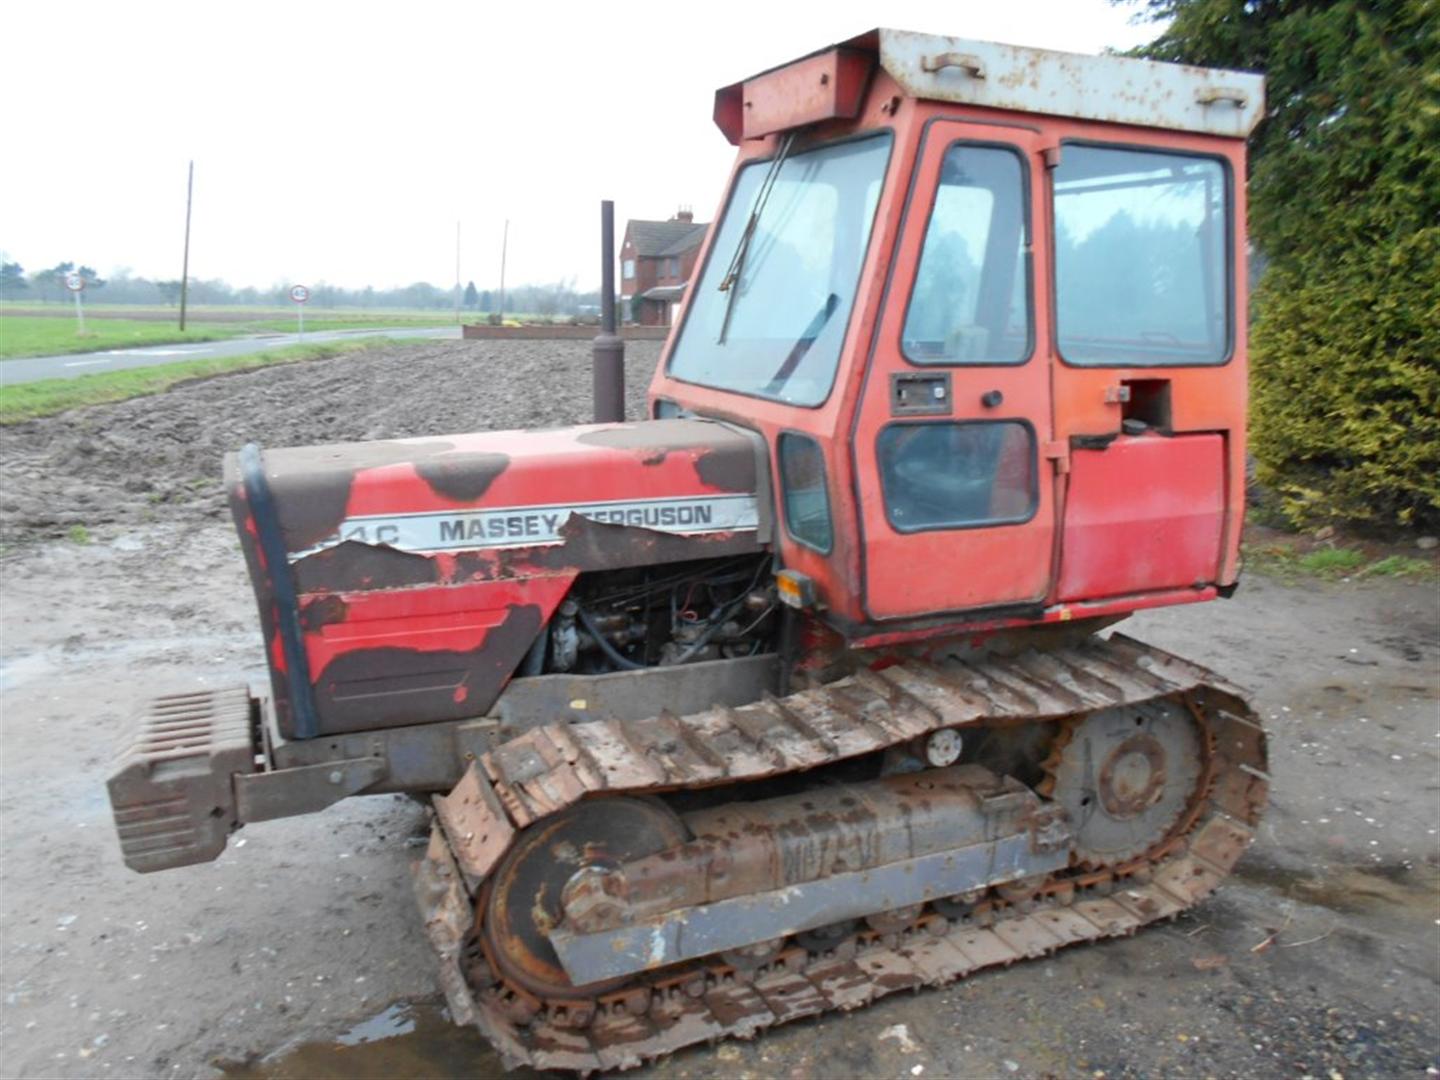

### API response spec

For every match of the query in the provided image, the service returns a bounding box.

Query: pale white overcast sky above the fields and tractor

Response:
[0,0,1156,288]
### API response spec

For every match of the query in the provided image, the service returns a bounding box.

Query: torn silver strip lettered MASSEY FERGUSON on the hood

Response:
[289,495,759,562]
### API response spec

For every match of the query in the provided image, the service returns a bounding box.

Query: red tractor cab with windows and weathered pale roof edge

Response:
[651,30,1263,639]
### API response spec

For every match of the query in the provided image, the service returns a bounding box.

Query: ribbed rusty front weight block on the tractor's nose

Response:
[107,685,256,873]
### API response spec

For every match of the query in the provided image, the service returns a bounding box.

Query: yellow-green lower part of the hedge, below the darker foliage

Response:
[1250,228,1440,527]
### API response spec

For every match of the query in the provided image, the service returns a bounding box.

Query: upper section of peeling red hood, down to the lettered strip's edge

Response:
[256,420,759,562]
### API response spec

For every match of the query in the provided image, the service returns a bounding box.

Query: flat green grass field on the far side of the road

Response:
[0,305,460,360]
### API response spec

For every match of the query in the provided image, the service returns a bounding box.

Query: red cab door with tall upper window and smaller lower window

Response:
[852,120,1056,621]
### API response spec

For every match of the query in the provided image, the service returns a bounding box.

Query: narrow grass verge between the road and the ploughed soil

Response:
[0,337,413,425]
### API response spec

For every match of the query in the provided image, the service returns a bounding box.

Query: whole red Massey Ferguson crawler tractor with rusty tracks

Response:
[109,30,1267,1073]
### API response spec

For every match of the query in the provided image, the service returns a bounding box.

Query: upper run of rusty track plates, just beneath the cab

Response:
[484,635,1238,825]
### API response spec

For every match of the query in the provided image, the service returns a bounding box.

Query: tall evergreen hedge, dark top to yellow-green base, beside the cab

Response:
[1120,0,1440,528]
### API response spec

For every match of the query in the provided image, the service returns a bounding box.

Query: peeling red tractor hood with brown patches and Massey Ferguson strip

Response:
[226,419,770,737]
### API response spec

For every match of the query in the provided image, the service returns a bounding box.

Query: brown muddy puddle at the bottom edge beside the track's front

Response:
[220,1001,547,1080]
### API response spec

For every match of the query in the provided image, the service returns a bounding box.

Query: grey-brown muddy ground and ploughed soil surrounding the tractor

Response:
[0,343,1440,1077]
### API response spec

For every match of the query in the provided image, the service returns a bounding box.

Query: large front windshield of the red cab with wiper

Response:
[670,132,890,405]
